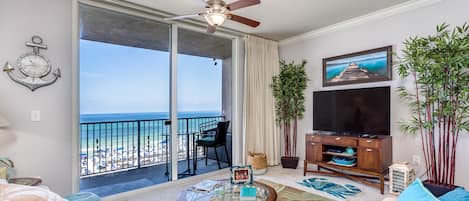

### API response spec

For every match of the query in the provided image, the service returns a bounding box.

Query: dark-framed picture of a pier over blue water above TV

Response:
[322,46,392,87]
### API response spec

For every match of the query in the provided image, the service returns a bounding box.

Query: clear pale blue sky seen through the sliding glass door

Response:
[80,40,222,114]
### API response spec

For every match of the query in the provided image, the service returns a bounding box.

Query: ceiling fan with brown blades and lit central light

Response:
[165,0,261,33]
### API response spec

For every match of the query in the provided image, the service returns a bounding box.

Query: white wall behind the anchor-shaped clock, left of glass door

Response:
[0,0,72,194]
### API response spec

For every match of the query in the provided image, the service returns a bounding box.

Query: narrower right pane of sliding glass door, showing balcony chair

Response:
[177,28,232,178]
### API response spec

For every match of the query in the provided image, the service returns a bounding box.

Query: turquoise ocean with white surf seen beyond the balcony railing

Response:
[80,111,223,155]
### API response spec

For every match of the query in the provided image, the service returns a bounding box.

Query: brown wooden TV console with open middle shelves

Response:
[303,133,392,194]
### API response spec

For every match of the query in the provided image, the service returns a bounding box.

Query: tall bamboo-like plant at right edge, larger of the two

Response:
[398,24,469,185]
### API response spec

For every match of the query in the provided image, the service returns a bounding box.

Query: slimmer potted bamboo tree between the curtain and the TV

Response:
[272,60,308,169]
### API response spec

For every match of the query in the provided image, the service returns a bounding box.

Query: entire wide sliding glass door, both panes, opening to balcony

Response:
[78,4,238,197]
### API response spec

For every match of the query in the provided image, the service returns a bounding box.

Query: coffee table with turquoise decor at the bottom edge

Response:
[178,180,277,201]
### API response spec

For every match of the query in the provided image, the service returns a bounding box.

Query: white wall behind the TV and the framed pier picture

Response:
[280,0,469,188]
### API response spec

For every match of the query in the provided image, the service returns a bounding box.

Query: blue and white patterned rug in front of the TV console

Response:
[297,177,362,199]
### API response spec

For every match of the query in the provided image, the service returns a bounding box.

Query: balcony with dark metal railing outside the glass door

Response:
[80,116,231,196]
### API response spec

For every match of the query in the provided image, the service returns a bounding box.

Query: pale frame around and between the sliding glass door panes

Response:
[71,0,241,195]
